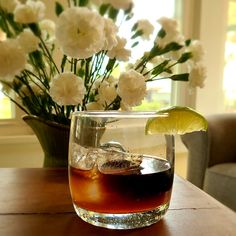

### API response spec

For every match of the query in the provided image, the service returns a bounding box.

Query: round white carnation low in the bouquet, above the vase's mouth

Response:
[50,72,86,105]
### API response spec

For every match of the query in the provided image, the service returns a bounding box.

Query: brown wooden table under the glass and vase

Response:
[0,169,236,236]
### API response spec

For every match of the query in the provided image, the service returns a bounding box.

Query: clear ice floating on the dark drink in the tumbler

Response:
[70,143,143,174]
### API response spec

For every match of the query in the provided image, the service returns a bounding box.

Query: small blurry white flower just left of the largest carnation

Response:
[39,19,56,43]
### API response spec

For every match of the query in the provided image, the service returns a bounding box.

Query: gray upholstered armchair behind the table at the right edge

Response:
[181,113,236,211]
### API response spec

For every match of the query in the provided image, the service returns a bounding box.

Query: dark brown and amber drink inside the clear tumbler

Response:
[69,157,173,213]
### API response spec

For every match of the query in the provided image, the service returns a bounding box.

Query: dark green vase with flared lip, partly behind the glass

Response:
[22,115,70,167]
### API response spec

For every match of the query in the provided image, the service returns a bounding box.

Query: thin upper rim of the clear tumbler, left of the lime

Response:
[72,110,166,118]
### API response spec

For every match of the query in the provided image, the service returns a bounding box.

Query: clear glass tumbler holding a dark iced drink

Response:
[69,111,174,229]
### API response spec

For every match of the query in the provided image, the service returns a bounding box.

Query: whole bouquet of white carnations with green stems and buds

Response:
[0,0,206,125]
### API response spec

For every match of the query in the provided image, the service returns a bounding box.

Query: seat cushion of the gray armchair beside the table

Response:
[203,163,236,211]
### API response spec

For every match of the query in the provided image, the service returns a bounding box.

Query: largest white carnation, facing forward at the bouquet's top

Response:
[56,7,104,59]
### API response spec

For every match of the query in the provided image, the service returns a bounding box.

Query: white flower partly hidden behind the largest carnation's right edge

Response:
[103,18,118,50]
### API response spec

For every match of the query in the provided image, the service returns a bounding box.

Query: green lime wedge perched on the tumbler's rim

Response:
[145,106,207,134]
